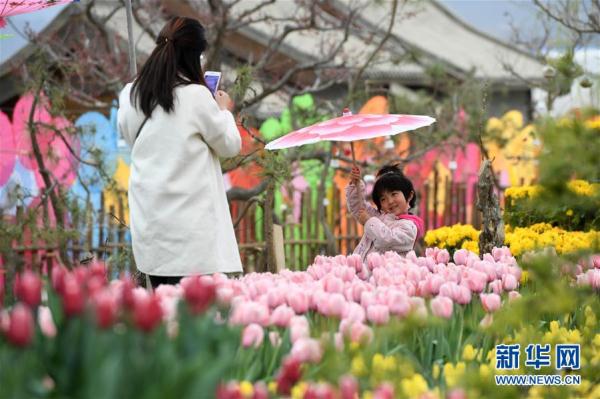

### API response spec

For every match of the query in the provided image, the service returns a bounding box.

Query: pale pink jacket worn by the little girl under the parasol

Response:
[346,181,423,262]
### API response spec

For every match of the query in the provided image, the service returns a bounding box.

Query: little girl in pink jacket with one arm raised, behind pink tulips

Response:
[346,165,424,262]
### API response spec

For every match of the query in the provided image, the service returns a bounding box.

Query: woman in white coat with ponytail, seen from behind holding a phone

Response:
[118,17,242,286]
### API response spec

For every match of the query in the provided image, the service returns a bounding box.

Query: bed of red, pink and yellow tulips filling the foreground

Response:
[0,242,600,399]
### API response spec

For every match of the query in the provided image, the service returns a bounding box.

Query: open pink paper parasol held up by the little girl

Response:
[265,109,435,163]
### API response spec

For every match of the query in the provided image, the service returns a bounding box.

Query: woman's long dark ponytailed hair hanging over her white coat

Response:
[131,17,207,117]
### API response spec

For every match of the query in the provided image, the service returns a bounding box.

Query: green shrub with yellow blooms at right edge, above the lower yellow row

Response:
[504,180,600,231]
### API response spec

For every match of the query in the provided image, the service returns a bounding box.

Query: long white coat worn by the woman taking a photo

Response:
[118,83,242,276]
